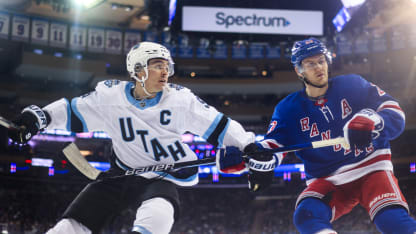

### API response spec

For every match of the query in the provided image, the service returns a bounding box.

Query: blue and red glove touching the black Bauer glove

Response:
[215,146,247,174]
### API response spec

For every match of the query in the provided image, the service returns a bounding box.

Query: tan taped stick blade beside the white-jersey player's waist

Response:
[62,143,101,180]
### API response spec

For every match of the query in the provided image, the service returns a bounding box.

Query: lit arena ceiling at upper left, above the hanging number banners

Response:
[0,0,150,29]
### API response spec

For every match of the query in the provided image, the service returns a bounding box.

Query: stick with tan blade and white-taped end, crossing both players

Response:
[63,137,346,180]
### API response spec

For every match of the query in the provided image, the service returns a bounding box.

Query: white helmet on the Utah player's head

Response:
[126,42,174,82]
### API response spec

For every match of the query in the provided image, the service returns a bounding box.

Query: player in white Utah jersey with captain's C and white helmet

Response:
[9,42,255,234]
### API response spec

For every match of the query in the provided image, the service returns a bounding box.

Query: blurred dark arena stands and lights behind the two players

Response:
[0,0,416,234]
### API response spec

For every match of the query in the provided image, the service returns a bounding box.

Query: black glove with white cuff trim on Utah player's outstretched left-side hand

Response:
[8,105,47,144]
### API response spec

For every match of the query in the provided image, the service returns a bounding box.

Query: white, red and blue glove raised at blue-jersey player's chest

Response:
[344,109,384,150]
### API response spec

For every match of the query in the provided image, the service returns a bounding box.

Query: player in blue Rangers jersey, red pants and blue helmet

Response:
[219,38,416,234]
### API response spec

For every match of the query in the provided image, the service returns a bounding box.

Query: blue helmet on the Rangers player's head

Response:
[291,37,332,68]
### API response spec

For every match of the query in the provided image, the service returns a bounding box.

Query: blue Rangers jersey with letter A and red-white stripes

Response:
[260,75,405,185]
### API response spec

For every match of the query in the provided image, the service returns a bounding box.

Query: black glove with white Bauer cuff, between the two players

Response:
[244,143,276,192]
